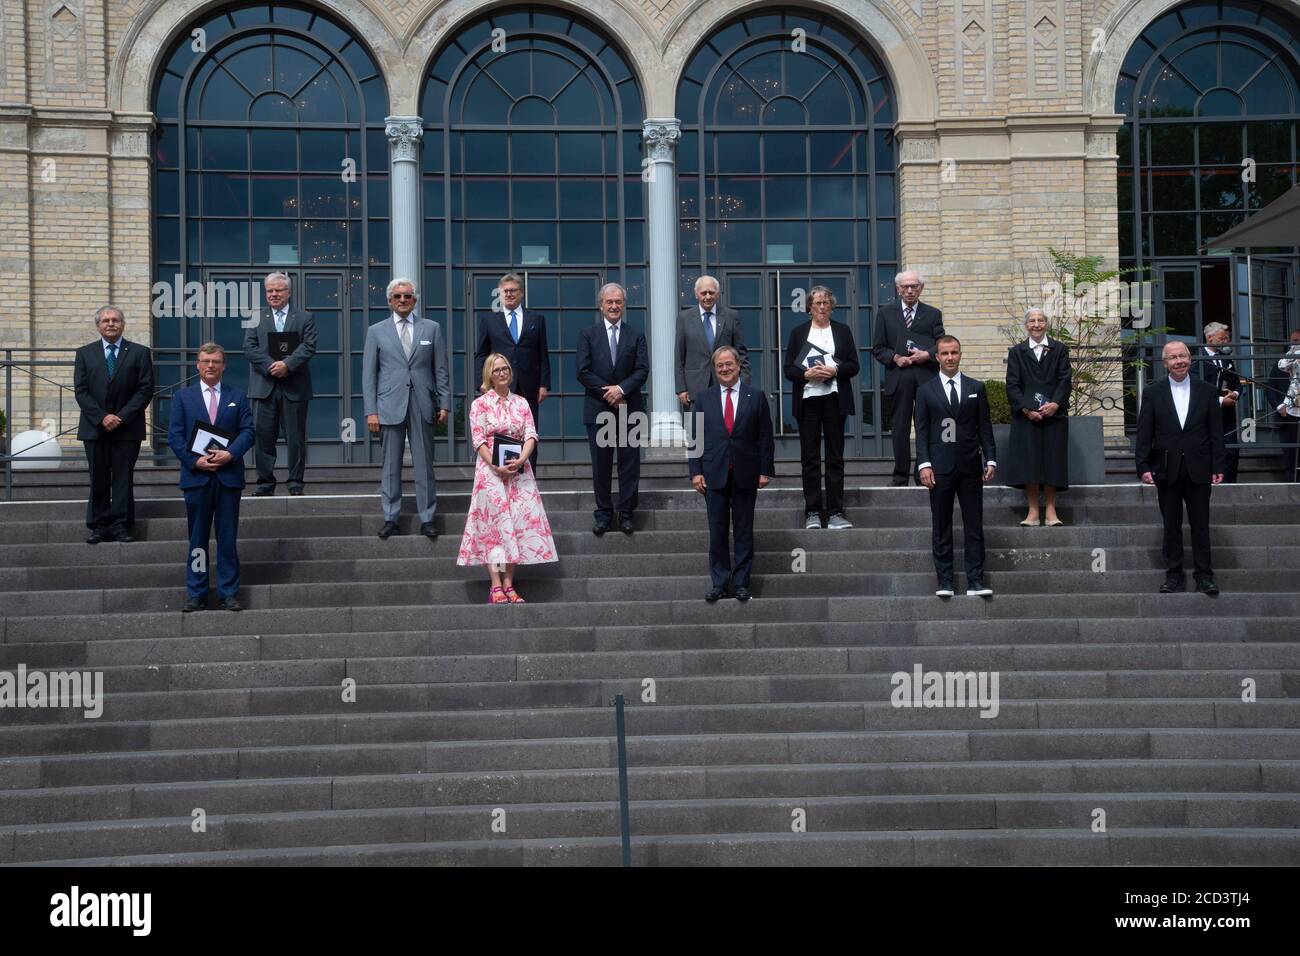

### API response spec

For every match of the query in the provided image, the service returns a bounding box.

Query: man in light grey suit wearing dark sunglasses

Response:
[361,278,451,541]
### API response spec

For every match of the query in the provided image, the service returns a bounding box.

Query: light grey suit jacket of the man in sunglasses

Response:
[361,312,451,425]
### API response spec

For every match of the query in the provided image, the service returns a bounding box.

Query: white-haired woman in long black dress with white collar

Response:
[1002,308,1070,527]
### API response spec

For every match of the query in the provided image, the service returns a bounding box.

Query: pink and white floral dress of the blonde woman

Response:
[456,392,558,564]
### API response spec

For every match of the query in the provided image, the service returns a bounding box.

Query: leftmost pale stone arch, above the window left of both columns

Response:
[108,0,402,113]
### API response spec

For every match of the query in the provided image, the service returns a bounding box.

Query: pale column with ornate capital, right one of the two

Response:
[641,118,685,458]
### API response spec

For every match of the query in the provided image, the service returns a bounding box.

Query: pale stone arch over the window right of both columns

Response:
[659,0,939,122]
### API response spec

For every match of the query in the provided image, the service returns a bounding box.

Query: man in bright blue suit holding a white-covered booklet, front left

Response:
[166,342,255,613]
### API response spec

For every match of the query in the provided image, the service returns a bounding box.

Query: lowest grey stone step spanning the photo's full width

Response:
[0,793,1300,864]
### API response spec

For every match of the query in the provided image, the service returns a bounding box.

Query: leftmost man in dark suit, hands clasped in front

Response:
[73,306,153,545]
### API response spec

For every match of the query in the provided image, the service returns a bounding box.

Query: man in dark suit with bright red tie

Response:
[689,345,776,601]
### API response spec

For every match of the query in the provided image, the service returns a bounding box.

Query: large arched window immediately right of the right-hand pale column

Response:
[677,10,898,454]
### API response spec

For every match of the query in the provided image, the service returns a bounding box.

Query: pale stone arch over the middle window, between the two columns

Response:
[405,0,660,116]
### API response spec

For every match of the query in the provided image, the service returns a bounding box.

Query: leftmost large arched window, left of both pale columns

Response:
[153,3,389,460]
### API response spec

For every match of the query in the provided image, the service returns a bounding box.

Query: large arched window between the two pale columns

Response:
[423,8,646,457]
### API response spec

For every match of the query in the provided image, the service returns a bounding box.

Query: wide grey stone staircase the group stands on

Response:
[0,481,1300,865]
